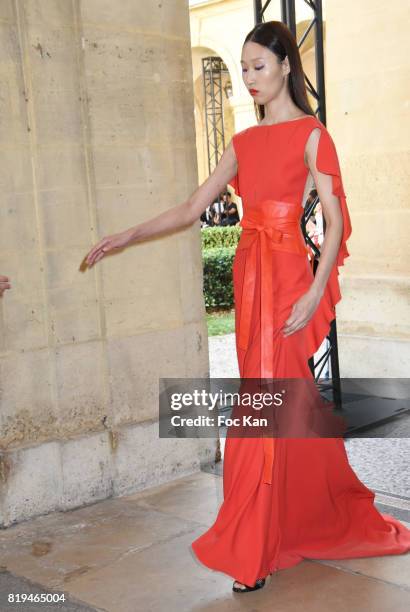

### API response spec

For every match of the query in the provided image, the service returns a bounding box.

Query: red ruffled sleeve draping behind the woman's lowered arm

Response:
[306,123,352,357]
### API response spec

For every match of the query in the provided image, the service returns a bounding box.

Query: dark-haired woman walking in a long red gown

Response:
[87,21,410,592]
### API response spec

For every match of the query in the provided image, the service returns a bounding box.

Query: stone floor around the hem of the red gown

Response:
[0,336,410,612]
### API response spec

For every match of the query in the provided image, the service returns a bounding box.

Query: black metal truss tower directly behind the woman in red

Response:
[254,0,341,408]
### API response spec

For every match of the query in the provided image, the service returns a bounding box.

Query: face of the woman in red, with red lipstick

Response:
[241,42,289,105]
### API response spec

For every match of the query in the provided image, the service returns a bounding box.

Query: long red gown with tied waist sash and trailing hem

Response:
[191,116,410,585]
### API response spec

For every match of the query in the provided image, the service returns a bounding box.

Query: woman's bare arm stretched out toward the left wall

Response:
[86,140,238,266]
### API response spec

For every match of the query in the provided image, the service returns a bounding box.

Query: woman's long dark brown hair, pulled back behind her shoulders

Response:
[243,21,315,121]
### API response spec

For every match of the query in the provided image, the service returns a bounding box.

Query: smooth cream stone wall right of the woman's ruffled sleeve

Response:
[326,0,410,377]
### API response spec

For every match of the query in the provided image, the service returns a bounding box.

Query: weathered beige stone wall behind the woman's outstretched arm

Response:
[0,0,211,526]
